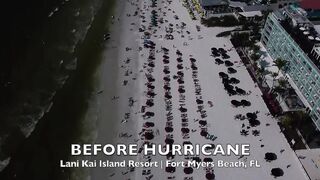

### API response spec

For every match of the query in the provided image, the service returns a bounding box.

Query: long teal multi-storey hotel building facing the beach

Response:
[261,6,320,130]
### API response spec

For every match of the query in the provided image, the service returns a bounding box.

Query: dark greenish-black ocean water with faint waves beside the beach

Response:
[0,0,115,180]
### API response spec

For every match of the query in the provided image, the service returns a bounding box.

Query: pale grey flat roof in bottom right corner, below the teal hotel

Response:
[296,148,320,180]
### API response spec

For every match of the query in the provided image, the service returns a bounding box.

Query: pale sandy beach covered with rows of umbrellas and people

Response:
[91,0,307,180]
